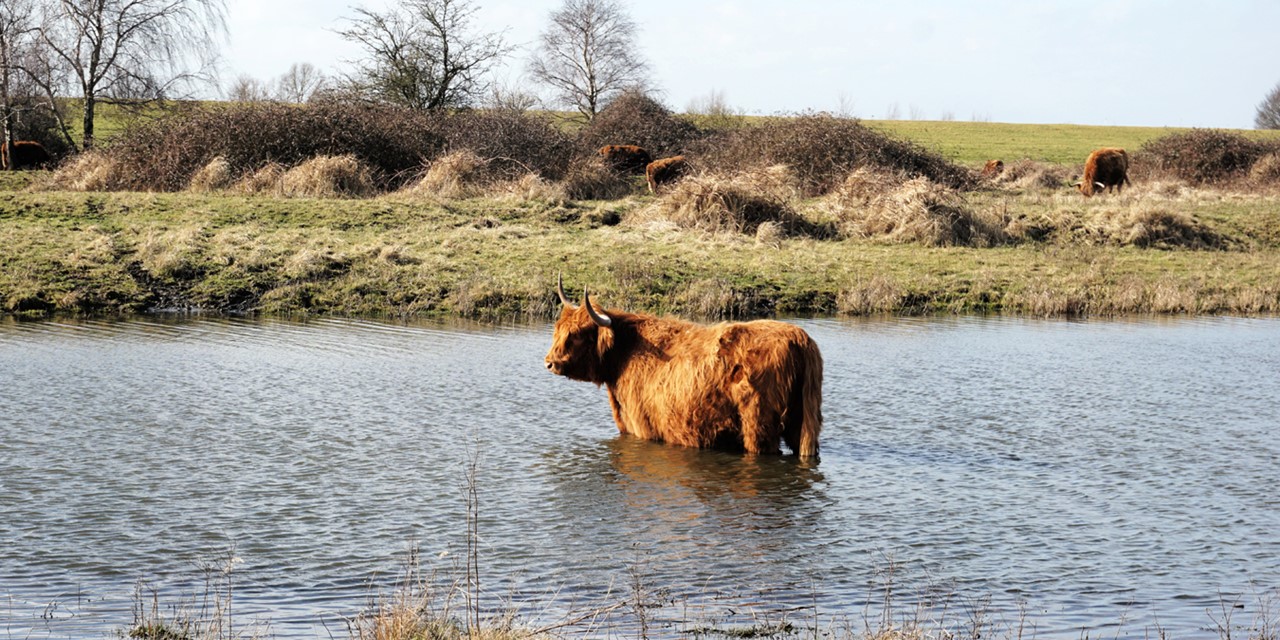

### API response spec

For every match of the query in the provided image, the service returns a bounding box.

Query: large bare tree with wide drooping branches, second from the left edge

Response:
[33,0,227,148]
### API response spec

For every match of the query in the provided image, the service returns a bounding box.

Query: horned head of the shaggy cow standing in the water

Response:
[545,272,613,384]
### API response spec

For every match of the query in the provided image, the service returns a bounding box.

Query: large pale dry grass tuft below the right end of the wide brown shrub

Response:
[831,168,1007,247]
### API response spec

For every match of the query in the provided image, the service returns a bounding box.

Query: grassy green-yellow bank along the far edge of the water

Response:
[0,184,1280,320]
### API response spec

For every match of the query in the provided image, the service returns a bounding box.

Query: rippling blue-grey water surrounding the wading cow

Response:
[0,319,1280,637]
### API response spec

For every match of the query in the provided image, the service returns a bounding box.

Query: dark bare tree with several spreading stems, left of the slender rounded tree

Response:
[338,0,508,109]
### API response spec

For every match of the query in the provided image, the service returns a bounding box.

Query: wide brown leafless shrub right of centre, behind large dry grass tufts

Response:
[694,114,977,196]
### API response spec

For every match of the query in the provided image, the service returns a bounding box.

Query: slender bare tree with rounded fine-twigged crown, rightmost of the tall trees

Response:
[529,0,649,119]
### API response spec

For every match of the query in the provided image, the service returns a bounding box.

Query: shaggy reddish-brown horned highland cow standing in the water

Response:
[547,275,822,458]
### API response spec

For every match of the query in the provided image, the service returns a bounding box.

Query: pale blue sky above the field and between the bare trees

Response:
[223,0,1280,128]
